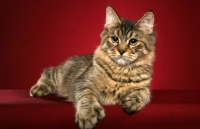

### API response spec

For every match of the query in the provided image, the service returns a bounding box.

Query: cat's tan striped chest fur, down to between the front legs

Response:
[92,58,150,104]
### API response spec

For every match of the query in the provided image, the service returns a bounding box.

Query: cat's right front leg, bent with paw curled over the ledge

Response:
[122,87,150,114]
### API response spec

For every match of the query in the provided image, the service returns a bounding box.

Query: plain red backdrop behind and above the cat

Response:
[0,0,200,89]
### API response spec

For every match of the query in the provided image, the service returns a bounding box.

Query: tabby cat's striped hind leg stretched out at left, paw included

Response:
[30,67,59,97]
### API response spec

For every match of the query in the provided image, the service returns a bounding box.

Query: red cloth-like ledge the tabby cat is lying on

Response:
[0,90,200,129]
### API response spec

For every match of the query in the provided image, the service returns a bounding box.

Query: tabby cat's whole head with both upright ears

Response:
[100,6,155,66]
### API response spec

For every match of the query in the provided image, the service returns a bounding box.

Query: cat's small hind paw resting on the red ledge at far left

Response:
[30,85,51,97]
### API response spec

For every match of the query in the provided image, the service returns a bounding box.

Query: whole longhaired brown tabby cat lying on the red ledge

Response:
[30,6,155,129]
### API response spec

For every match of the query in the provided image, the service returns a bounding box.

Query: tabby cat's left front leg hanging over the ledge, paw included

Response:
[75,81,105,129]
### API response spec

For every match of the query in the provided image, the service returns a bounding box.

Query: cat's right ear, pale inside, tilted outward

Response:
[136,12,154,34]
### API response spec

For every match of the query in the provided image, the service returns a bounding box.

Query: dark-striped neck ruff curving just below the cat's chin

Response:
[93,47,152,88]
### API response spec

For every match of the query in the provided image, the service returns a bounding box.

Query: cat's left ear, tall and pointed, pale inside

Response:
[105,6,121,28]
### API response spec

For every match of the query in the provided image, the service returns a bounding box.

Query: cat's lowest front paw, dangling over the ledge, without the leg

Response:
[75,104,105,129]
